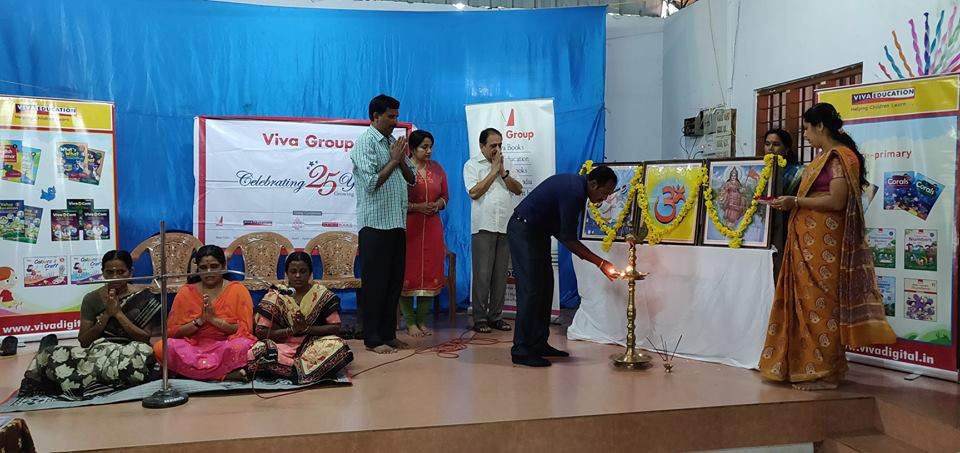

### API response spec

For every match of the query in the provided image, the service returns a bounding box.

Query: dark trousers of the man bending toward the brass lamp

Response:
[507,216,553,355]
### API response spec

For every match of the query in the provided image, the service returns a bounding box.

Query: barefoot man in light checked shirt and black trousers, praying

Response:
[350,94,416,354]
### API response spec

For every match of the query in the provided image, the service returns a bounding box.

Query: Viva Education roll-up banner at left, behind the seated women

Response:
[0,97,117,341]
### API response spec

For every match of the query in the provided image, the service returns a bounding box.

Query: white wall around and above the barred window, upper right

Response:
[663,0,956,159]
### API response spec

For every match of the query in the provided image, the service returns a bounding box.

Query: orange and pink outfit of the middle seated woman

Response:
[154,282,256,380]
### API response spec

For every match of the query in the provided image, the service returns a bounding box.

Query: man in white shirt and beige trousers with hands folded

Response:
[463,128,523,333]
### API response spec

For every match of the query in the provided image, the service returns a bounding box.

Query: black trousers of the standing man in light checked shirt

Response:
[357,227,407,348]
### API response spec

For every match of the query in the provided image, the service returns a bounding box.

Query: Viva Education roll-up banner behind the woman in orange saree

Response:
[818,75,960,380]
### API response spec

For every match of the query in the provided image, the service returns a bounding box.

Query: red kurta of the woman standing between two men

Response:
[401,160,449,296]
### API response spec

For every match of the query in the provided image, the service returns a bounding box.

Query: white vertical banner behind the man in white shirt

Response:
[466,99,560,317]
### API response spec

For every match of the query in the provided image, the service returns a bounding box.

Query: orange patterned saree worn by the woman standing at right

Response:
[759,148,896,382]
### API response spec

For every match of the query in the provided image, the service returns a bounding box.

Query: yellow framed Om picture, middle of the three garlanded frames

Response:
[643,161,703,244]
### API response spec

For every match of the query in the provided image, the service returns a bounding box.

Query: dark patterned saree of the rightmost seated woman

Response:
[248,283,353,384]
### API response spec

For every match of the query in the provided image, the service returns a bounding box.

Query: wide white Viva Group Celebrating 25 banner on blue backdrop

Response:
[194,117,409,248]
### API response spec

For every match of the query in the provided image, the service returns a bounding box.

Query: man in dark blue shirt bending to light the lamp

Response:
[507,166,618,367]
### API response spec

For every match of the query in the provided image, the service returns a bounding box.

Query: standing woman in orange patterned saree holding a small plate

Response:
[760,103,896,390]
